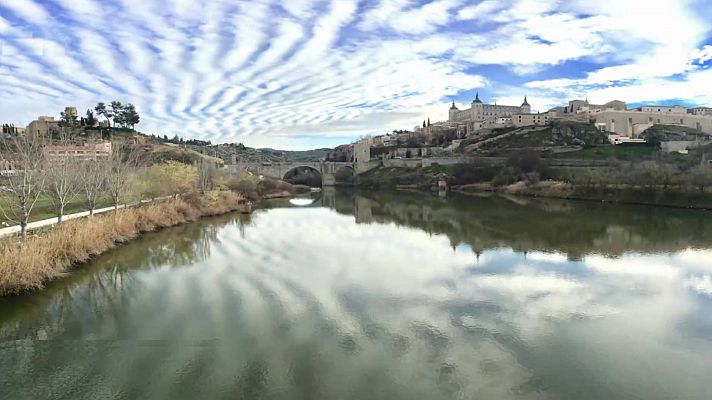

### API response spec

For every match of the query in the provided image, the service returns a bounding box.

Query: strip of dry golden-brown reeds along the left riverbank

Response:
[0,191,245,296]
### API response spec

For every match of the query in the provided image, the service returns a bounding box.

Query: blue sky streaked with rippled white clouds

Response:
[0,0,712,149]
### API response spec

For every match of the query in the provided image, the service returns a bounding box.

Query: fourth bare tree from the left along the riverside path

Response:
[103,142,139,211]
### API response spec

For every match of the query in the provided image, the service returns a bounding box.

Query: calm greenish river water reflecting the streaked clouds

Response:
[0,192,712,400]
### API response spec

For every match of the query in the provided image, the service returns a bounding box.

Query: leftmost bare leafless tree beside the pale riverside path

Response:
[0,134,46,240]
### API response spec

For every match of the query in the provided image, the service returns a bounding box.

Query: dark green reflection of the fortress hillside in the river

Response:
[321,191,712,260]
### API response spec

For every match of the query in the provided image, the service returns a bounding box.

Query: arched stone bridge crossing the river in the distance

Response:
[225,161,380,186]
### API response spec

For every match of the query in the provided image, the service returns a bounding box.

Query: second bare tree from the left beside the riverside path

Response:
[47,128,79,224]
